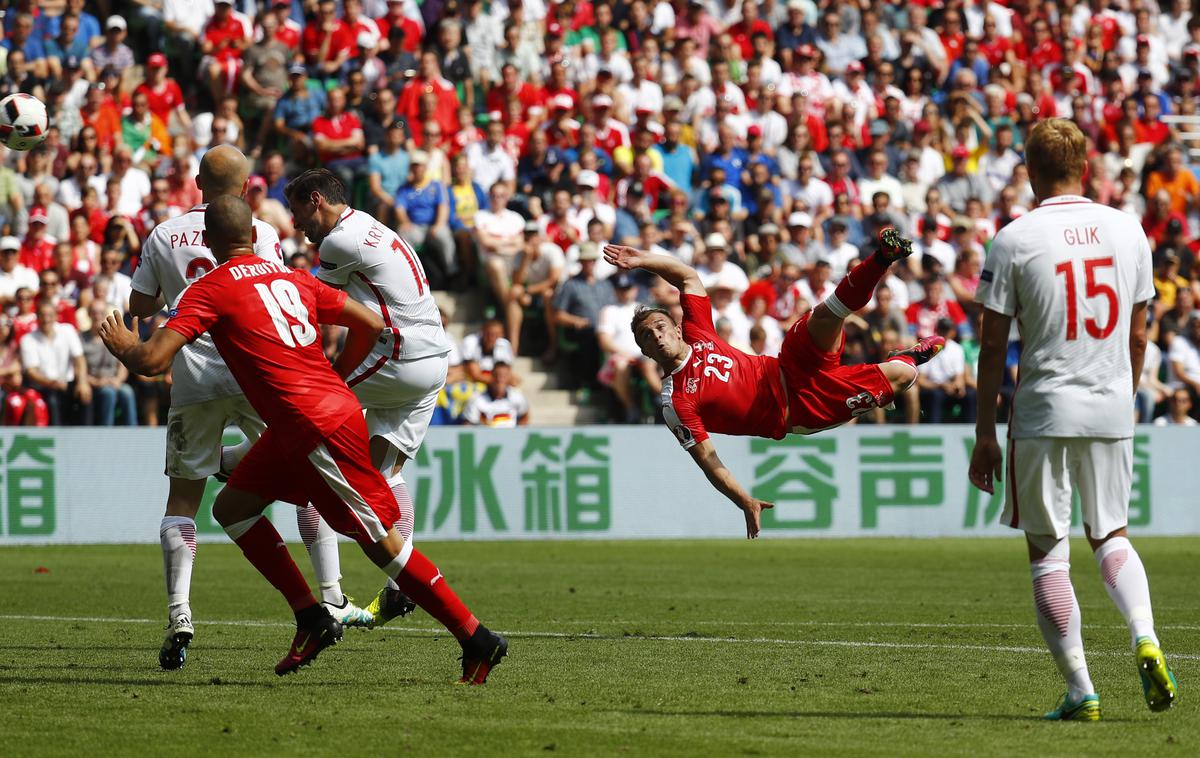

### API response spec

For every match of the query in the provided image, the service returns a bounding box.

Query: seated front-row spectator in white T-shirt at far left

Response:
[20,302,91,426]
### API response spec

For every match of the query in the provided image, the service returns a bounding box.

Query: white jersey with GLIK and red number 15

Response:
[976,195,1154,439]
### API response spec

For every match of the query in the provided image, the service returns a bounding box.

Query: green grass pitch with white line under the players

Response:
[0,537,1200,756]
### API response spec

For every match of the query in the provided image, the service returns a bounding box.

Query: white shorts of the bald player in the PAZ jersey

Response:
[167,395,266,480]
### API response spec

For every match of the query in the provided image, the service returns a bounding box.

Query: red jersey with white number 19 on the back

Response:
[166,255,361,453]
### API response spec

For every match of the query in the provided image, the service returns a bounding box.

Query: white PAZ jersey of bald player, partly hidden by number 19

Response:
[133,205,283,405]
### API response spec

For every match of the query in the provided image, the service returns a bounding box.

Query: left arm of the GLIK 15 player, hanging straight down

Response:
[967,308,1013,494]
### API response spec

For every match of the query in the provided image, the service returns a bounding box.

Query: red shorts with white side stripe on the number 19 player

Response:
[229,411,400,545]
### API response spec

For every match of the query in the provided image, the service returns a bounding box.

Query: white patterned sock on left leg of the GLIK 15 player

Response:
[1030,540,1096,702]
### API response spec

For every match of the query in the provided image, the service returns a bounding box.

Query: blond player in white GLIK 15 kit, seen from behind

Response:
[970,119,1176,721]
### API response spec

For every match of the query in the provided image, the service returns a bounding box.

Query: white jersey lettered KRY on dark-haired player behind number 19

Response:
[317,207,450,408]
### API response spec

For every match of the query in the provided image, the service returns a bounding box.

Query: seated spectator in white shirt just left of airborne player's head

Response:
[596,271,662,423]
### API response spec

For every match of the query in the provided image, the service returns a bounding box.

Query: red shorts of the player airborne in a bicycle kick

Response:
[779,314,893,434]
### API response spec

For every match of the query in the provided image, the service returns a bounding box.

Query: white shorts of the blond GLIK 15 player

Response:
[1001,437,1133,540]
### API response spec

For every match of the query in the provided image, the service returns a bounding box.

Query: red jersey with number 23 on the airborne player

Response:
[662,295,787,450]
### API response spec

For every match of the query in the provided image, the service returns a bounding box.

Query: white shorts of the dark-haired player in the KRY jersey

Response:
[354,355,449,458]
